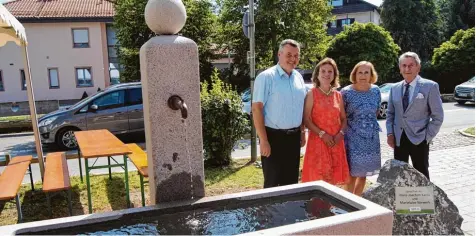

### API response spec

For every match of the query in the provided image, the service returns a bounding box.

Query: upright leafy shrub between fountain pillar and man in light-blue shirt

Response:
[200,69,250,166]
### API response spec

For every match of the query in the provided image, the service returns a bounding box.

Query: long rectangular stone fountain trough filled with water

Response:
[0,181,393,235]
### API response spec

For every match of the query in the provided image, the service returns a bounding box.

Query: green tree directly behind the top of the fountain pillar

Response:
[114,0,217,82]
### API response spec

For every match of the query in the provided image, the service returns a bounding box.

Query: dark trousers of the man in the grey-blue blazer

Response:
[394,132,430,180]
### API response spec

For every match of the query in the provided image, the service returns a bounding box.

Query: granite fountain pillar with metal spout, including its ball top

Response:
[140,0,205,205]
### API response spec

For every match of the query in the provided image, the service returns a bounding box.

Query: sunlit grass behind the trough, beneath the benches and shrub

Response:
[0,158,368,225]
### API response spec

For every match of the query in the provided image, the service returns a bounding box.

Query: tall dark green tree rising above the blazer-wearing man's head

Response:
[381,0,442,62]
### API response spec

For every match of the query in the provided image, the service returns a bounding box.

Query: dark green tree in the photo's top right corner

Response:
[437,0,474,40]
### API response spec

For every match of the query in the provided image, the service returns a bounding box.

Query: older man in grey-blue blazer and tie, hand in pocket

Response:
[387,52,444,179]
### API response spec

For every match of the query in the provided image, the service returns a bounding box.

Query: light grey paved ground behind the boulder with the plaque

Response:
[369,145,475,235]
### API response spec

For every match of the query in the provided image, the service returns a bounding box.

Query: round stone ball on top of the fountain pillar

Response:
[144,0,187,35]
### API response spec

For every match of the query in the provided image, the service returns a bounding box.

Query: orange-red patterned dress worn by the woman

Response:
[302,88,349,185]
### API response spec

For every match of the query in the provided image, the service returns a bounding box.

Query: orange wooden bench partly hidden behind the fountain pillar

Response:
[126,143,149,206]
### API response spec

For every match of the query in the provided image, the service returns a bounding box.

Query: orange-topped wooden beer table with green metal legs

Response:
[74,129,132,213]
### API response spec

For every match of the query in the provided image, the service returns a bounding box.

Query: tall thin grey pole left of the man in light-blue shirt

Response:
[248,0,257,162]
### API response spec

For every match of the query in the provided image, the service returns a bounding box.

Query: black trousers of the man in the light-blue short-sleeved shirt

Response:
[261,127,301,188]
